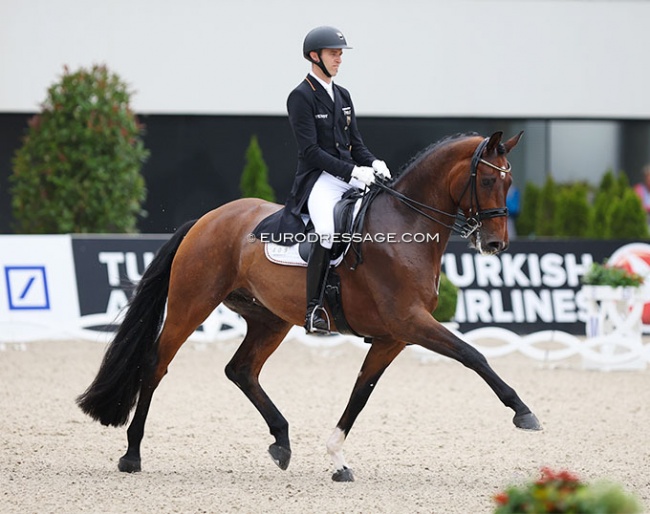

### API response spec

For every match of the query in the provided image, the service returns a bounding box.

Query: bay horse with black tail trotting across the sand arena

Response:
[77,132,541,481]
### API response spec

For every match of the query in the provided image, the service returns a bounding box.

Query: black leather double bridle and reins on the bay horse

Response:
[375,137,512,238]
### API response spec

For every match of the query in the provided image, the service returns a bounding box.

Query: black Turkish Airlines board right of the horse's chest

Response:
[442,240,644,334]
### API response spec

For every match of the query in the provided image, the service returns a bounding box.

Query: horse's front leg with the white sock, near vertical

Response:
[327,340,405,482]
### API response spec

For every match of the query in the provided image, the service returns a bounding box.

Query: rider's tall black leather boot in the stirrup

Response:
[305,242,332,334]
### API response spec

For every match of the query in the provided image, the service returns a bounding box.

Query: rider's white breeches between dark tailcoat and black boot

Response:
[307,171,365,248]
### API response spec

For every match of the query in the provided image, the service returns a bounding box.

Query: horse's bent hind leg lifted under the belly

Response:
[225,311,291,470]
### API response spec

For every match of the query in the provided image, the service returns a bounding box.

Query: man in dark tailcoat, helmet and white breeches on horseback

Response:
[285,27,391,332]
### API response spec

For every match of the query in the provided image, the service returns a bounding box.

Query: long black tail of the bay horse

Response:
[77,220,196,427]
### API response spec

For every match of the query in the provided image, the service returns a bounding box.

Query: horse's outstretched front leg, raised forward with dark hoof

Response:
[407,313,542,430]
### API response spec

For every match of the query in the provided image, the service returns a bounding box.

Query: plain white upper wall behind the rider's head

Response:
[0,0,650,119]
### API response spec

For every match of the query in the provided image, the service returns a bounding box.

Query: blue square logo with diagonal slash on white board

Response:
[5,266,50,310]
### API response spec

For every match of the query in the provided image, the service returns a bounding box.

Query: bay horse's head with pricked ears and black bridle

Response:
[450,132,523,254]
